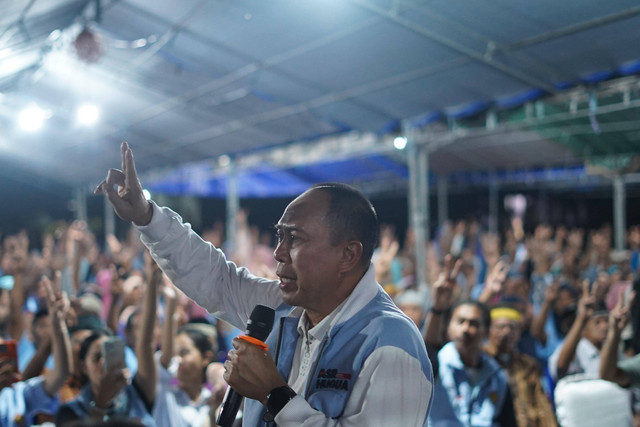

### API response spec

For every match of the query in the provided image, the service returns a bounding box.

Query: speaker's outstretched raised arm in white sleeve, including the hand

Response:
[96,142,282,328]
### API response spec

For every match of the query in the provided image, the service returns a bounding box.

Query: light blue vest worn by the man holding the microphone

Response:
[243,288,433,427]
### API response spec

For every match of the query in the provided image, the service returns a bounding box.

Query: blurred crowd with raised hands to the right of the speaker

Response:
[374,218,640,426]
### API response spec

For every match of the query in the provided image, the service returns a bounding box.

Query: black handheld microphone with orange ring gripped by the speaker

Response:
[216,305,275,427]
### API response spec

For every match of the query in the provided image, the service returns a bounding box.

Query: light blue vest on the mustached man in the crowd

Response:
[429,342,508,427]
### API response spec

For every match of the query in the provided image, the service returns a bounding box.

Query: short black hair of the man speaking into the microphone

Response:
[311,182,378,268]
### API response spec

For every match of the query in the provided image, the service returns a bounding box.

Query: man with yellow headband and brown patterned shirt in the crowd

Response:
[485,305,556,427]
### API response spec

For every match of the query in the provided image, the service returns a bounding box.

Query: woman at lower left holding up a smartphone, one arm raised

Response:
[56,257,162,426]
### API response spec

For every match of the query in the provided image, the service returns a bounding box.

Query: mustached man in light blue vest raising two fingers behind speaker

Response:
[425,255,516,427]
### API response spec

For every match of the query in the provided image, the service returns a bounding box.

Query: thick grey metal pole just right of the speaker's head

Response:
[404,122,429,304]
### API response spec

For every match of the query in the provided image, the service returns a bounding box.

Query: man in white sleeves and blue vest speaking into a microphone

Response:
[97,143,433,426]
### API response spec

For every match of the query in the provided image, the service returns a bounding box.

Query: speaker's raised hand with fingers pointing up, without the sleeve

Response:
[95,142,153,225]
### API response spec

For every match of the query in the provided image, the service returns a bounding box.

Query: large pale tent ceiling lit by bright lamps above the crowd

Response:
[0,0,640,194]
